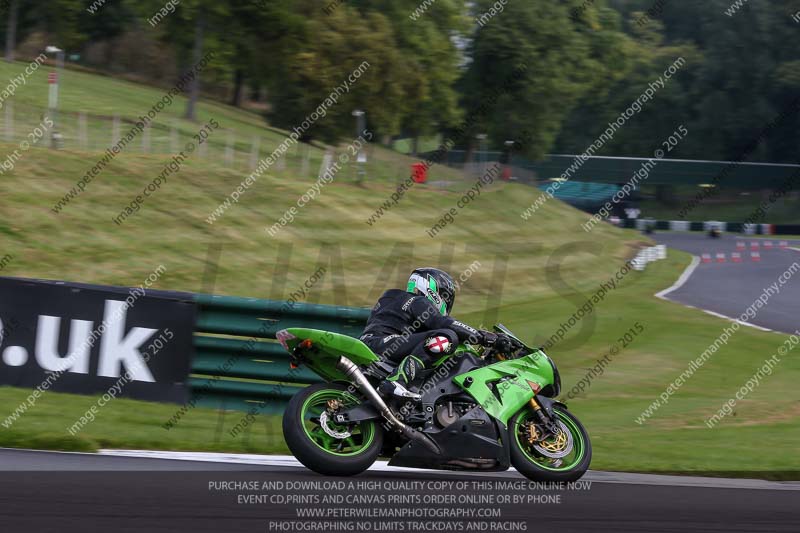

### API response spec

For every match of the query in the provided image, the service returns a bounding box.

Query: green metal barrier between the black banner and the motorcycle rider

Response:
[189,294,370,414]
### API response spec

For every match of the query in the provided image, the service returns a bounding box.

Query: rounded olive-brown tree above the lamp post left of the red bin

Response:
[268,2,414,142]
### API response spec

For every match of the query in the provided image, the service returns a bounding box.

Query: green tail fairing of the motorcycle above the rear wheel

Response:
[283,328,379,381]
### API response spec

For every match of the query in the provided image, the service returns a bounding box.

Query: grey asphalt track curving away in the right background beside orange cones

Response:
[653,233,800,332]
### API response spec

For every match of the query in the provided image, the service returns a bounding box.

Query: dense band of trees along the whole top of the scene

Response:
[2,0,800,162]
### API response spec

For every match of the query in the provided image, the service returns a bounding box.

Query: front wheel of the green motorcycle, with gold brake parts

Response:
[508,407,592,482]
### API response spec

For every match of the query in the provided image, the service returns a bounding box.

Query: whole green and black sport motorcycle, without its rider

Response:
[277,324,592,481]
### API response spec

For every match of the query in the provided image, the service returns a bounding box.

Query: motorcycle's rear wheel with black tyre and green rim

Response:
[283,383,383,476]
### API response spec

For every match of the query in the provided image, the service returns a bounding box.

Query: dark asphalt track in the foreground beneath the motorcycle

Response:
[0,450,800,533]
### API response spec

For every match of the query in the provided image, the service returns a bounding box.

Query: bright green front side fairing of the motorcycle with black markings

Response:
[453,350,554,425]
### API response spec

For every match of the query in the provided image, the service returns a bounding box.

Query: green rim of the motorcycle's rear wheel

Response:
[300,389,375,457]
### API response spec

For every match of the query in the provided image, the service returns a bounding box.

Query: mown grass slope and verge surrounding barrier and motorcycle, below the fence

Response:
[0,63,800,476]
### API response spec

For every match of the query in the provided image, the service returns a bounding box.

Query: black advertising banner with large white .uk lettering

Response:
[0,277,196,403]
